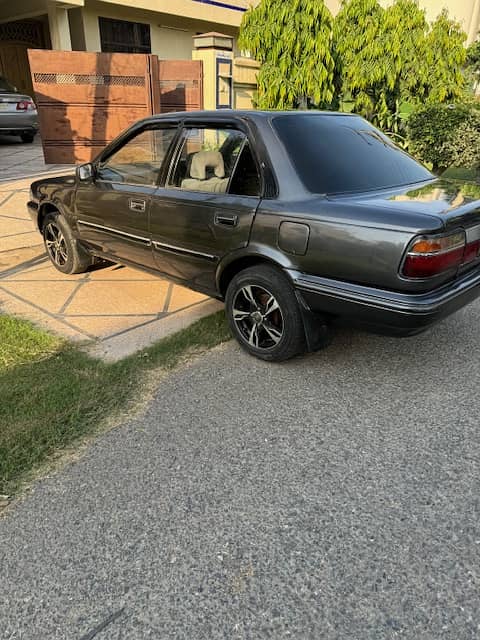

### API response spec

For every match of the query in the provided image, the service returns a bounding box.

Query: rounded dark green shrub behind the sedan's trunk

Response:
[408,104,474,171]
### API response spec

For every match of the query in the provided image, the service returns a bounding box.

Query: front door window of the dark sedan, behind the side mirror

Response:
[97,127,177,186]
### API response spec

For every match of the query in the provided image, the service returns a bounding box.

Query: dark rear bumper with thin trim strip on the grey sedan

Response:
[290,269,480,335]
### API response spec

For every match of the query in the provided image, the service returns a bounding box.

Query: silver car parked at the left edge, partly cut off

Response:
[0,76,38,142]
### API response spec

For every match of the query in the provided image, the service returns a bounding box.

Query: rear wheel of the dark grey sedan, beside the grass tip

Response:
[225,264,306,362]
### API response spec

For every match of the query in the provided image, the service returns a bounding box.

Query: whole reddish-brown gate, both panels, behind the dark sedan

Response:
[28,50,202,164]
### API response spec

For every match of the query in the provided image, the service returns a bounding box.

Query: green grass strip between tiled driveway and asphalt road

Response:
[0,312,230,494]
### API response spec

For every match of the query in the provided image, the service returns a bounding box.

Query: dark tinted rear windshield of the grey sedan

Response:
[273,114,432,194]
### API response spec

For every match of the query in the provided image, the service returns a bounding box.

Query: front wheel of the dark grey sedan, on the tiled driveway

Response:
[42,212,93,274]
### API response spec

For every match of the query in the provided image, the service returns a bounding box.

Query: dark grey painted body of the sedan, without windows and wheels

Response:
[30,112,480,340]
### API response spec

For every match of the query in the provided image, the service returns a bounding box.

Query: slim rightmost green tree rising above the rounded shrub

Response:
[426,9,467,103]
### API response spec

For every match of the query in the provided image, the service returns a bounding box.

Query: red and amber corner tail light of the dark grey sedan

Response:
[402,231,464,278]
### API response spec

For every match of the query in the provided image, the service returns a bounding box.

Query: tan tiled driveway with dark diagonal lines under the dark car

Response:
[0,179,221,358]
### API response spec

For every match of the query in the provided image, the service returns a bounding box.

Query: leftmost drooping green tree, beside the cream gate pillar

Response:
[239,0,335,109]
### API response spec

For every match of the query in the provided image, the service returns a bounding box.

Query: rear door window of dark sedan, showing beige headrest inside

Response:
[168,127,258,195]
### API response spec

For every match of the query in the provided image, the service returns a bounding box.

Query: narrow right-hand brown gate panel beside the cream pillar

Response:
[153,60,203,113]
